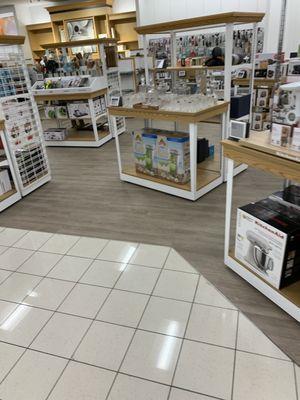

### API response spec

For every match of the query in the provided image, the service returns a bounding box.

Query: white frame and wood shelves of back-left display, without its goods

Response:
[33,39,125,147]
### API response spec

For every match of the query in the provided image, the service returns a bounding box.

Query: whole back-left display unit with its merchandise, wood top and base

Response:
[32,39,125,147]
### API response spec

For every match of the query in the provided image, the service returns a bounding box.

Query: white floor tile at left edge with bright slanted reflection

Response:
[0,305,52,347]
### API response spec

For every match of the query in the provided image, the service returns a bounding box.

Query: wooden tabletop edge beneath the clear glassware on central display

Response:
[108,101,229,123]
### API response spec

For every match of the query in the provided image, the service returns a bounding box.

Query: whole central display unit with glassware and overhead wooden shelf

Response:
[109,12,264,201]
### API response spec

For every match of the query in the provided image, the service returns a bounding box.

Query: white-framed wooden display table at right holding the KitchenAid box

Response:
[222,133,300,321]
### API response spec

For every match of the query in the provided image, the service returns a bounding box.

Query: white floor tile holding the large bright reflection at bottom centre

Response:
[120,331,181,385]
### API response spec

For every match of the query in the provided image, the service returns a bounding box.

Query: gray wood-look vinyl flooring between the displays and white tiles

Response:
[0,122,300,364]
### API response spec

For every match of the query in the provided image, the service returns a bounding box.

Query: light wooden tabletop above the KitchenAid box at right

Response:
[221,136,300,182]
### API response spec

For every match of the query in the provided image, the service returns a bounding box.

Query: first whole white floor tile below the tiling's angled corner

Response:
[153,270,198,301]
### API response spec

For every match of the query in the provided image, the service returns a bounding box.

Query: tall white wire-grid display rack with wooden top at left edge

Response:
[0,36,51,196]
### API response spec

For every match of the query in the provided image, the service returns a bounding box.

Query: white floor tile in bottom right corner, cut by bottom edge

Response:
[233,352,297,400]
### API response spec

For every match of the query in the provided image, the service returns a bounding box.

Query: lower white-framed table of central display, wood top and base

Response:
[109,101,229,201]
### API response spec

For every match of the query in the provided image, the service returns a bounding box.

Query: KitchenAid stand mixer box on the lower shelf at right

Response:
[235,203,300,289]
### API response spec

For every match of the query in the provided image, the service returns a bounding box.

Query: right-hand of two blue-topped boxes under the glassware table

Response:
[157,132,190,183]
